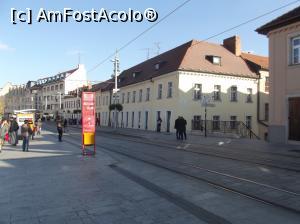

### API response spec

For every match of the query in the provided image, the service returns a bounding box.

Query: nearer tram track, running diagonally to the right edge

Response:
[44,126,300,215]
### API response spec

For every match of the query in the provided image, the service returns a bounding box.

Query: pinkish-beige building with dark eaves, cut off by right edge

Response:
[257,7,300,143]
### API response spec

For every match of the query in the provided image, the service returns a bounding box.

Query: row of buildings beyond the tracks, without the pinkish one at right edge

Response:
[1,36,269,138]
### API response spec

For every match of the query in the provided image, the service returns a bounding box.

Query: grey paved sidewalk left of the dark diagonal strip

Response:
[0,130,204,224]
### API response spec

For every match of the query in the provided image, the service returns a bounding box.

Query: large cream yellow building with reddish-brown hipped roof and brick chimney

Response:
[96,36,268,138]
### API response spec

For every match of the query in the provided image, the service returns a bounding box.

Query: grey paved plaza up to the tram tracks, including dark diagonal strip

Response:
[0,126,299,224]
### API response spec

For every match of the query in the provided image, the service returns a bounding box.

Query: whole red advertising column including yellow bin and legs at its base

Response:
[81,92,96,155]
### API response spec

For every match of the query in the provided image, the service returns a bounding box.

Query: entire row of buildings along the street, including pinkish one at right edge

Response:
[4,7,300,143]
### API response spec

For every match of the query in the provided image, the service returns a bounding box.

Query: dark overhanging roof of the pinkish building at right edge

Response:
[256,6,300,35]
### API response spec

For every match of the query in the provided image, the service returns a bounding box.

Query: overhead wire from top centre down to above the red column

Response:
[88,0,192,73]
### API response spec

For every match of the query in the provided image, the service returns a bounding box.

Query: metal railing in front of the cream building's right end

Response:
[191,120,259,139]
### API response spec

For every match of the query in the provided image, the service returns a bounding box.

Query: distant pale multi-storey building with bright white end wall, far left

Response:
[5,65,87,115]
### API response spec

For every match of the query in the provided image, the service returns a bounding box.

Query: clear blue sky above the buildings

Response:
[0,0,299,86]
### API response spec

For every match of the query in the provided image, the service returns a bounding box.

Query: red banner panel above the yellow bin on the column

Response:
[81,92,96,133]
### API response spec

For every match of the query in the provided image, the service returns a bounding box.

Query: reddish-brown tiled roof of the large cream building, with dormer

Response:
[118,40,257,87]
